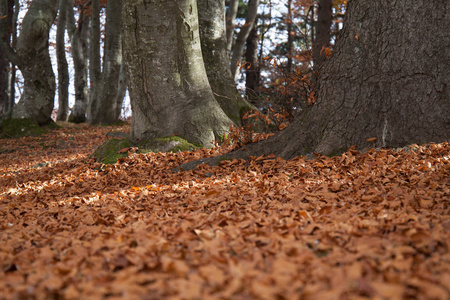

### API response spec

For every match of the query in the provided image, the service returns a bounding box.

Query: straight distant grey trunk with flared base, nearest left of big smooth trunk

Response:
[88,0,122,124]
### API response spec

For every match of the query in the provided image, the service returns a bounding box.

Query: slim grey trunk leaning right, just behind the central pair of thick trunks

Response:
[231,0,259,81]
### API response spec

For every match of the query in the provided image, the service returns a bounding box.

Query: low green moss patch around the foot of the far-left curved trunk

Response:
[0,119,46,138]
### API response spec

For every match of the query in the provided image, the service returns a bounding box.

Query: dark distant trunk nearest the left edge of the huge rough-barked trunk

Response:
[313,0,333,70]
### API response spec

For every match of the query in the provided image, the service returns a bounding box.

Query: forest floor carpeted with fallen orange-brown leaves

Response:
[0,125,450,300]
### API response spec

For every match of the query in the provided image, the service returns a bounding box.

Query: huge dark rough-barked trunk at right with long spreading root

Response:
[179,0,450,167]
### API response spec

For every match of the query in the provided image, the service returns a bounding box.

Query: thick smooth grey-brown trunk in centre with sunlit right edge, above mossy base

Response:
[124,0,231,146]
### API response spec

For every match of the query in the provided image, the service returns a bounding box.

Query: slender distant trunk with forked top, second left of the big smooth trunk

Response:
[67,0,90,123]
